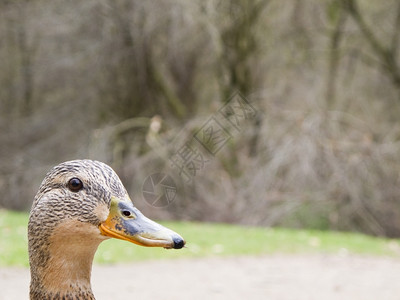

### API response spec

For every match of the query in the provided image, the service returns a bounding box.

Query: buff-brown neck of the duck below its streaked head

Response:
[30,222,102,300]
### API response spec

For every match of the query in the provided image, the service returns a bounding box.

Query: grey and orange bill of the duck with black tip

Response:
[99,197,185,249]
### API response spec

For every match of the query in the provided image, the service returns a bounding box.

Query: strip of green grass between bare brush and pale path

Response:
[0,210,400,266]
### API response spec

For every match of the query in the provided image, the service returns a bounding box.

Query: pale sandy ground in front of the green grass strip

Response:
[0,255,400,300]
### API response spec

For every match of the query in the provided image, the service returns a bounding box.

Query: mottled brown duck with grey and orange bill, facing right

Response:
[28,159,185,300]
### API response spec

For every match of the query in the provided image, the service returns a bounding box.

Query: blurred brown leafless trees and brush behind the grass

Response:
[0,0,400,237]
